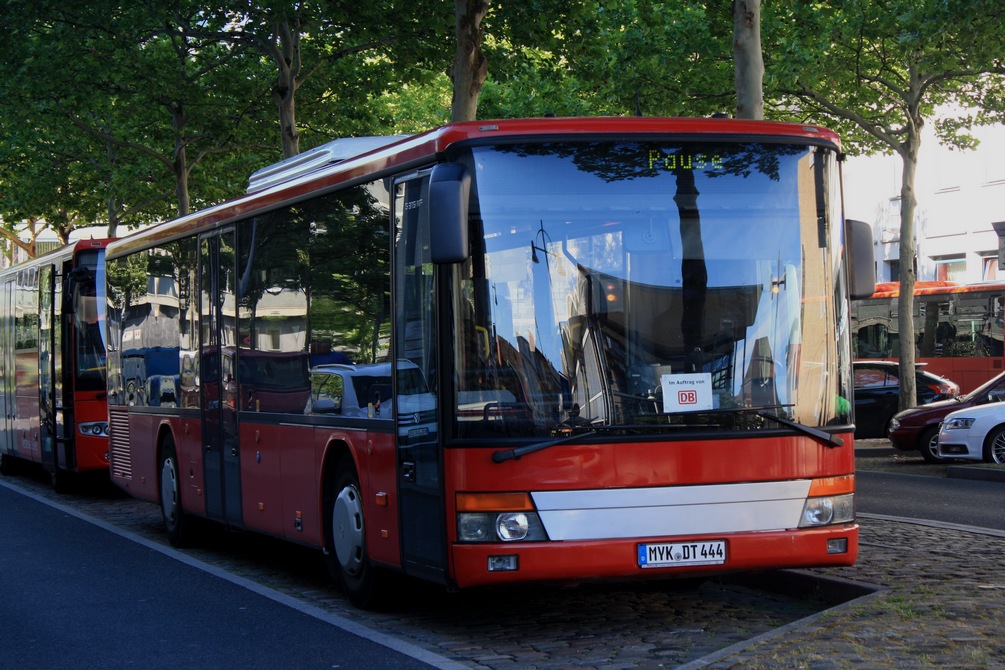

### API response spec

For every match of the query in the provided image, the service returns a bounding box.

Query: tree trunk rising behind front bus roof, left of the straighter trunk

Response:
[450,0,488,123]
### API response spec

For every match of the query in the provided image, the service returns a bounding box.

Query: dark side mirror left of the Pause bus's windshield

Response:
[429,163,471,263]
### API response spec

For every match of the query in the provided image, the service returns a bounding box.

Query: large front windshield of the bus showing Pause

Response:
[454,142,850,437]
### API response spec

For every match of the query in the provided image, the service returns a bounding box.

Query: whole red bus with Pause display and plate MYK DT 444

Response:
[99,118,875,607]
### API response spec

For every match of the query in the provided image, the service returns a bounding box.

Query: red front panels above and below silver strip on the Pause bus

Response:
[445,434,858,587]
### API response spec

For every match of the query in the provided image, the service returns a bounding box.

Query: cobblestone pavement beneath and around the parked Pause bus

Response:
[5,445,1005,670]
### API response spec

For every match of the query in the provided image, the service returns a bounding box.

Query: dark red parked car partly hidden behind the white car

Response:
[889,373,1005,463]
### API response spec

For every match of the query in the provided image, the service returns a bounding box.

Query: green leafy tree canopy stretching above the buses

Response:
[0,0,1003,277]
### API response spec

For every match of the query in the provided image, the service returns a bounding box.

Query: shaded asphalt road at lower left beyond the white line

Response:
[0,486,456,670]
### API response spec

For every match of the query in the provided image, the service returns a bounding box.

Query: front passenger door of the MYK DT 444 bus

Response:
[393,176,446,583]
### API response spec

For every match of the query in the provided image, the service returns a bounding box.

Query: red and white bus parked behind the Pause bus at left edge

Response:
[0,240,110,489]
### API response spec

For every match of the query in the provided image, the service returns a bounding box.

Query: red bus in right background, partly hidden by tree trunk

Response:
[851,281,1005,393]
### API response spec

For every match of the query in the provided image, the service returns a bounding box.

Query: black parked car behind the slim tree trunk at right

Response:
[852,361,960,438]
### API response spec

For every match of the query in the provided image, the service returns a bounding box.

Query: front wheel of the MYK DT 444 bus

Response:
[325,456,388,610]
